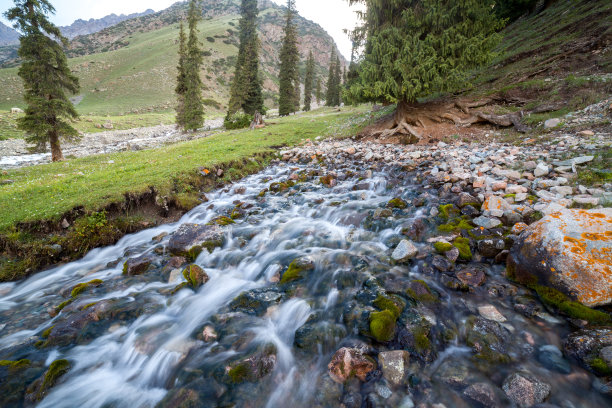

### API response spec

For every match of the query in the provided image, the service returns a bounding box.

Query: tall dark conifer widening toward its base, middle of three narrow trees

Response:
[228,0,264,116]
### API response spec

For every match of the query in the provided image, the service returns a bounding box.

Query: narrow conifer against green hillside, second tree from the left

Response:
[177,0,204,131]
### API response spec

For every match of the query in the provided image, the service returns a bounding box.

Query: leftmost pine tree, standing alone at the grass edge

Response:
[5,0,79,161]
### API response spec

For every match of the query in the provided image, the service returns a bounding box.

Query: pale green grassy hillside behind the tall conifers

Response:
[0,0,344,115]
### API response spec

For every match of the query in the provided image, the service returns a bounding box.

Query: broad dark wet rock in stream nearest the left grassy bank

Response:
[168,224,225,259]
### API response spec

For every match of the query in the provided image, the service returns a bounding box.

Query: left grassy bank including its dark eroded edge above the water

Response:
[0,106,372,281]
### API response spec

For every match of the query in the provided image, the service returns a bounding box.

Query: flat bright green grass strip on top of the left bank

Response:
[0,106,368,230]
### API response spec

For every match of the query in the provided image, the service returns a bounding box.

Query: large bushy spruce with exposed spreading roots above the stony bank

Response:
[350,0,503,128]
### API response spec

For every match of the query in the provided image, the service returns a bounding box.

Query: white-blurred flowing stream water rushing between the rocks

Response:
[0,163,610,408]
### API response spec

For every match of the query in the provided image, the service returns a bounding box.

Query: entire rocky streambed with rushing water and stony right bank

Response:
[0,138,612,408]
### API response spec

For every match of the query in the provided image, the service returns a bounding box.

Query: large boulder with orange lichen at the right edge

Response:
[508,208,612,307]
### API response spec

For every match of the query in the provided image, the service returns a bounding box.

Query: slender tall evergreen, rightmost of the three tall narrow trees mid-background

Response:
[278,0,299,116]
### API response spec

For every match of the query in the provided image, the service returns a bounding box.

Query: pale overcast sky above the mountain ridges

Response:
[0,0,364,59]
